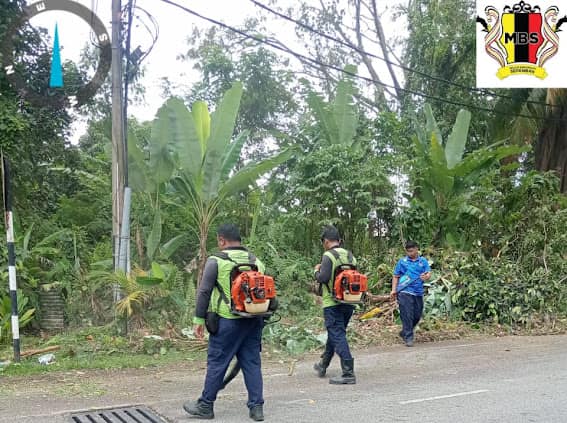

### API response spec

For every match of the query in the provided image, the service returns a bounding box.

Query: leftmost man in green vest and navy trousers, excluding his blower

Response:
[183,224,264,421]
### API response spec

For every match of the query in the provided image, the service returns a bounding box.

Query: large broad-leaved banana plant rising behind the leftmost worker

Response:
[138,82,294,280]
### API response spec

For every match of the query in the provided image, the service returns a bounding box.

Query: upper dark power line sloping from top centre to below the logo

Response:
[250,0,561,111]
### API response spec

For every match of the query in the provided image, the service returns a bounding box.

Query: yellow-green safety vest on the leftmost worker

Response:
[209,250,265,319]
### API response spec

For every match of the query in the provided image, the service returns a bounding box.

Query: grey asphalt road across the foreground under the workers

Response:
[0,335,567,423]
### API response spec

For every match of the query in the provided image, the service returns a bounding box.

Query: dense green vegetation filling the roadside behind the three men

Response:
[0,0,567,367]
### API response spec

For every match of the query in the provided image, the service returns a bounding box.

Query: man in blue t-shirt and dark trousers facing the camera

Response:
[390,241,431,347]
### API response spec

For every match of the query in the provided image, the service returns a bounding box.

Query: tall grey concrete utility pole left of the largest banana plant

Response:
[111,0,124,278]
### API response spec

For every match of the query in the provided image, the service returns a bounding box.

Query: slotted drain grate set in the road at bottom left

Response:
[71,406,166,423]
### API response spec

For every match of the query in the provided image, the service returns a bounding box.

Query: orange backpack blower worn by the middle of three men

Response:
[330,250,368,304]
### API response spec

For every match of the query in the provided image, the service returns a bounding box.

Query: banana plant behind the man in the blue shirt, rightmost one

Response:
[414,104,527,248]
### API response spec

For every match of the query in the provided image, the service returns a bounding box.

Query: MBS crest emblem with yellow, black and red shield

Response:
[476,1,567,79]
